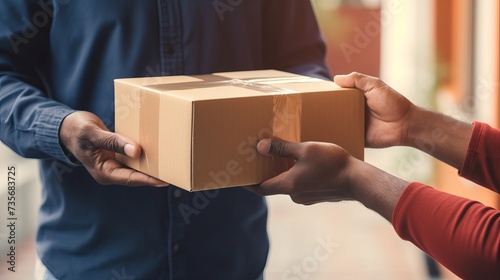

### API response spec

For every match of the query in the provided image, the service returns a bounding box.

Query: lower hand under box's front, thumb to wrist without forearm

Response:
[248,139,358,204]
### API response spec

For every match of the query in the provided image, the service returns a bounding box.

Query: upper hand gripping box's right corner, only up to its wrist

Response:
[334,72,419,148]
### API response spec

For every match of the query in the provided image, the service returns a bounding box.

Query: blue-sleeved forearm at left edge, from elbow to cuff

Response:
[0,73,73,160]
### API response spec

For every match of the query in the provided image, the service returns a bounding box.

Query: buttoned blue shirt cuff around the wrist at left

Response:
[35,107,80,166]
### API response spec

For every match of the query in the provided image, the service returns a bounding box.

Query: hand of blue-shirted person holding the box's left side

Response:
[59,111,168,186]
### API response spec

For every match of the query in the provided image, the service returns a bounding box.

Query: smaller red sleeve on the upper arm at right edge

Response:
[459,122,500,193]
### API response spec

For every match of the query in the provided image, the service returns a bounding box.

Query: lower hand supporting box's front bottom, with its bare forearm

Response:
[252,139,408,221]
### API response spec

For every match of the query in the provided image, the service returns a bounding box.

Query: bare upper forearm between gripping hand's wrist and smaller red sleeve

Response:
[403,108,472,169]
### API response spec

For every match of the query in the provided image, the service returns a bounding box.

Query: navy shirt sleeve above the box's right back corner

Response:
[263,0,332,80]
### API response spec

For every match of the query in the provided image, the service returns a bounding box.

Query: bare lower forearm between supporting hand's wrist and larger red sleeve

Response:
[347,158,408,221]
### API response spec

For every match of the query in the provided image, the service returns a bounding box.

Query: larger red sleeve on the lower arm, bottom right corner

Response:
[392,183,500,279]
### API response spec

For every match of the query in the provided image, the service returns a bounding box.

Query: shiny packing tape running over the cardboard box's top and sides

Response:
[139,75,310,174]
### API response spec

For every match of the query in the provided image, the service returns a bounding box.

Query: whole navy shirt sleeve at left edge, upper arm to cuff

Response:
[0,0,74,163]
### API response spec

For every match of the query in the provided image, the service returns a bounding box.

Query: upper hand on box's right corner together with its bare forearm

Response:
[335,73,472,169]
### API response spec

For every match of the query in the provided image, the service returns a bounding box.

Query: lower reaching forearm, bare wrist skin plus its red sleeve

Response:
[347,160,500,279]
